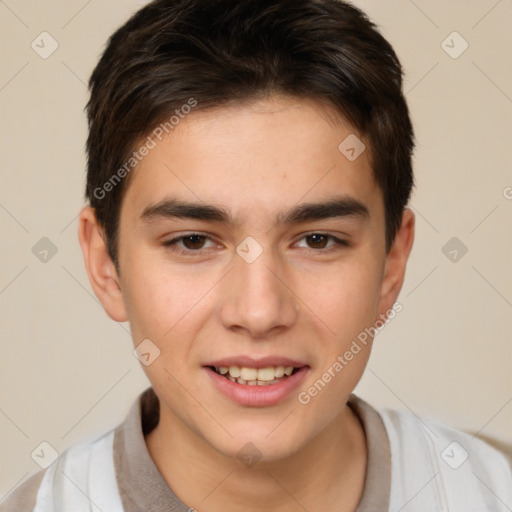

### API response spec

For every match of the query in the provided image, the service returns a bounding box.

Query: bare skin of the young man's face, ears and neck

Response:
[79,96,414,512]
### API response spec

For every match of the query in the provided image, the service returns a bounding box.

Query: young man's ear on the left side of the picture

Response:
[78,206,127,322]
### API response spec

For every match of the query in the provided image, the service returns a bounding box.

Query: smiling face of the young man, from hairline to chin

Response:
[84,97,412,460]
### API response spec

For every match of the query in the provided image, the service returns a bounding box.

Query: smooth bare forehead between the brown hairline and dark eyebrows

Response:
[121,96,383,223]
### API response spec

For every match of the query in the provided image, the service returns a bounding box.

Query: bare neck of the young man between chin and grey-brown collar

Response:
[146,406,367,512]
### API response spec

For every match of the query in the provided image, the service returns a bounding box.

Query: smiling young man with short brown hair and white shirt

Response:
[1,0,512,512]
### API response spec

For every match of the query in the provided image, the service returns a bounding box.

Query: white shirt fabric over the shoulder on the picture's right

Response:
[378,408,512,512]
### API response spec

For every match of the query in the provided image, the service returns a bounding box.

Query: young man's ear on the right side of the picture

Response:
[379,209,414,315]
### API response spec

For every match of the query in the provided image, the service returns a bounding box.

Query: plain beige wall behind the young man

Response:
[0,0,512,497]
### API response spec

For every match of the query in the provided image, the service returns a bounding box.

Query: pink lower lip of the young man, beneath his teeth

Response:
[205,366,309,407]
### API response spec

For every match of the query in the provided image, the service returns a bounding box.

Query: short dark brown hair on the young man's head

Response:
[86,0,414,268]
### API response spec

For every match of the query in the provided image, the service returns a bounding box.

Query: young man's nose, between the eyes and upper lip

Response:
[220,245,299,338]
